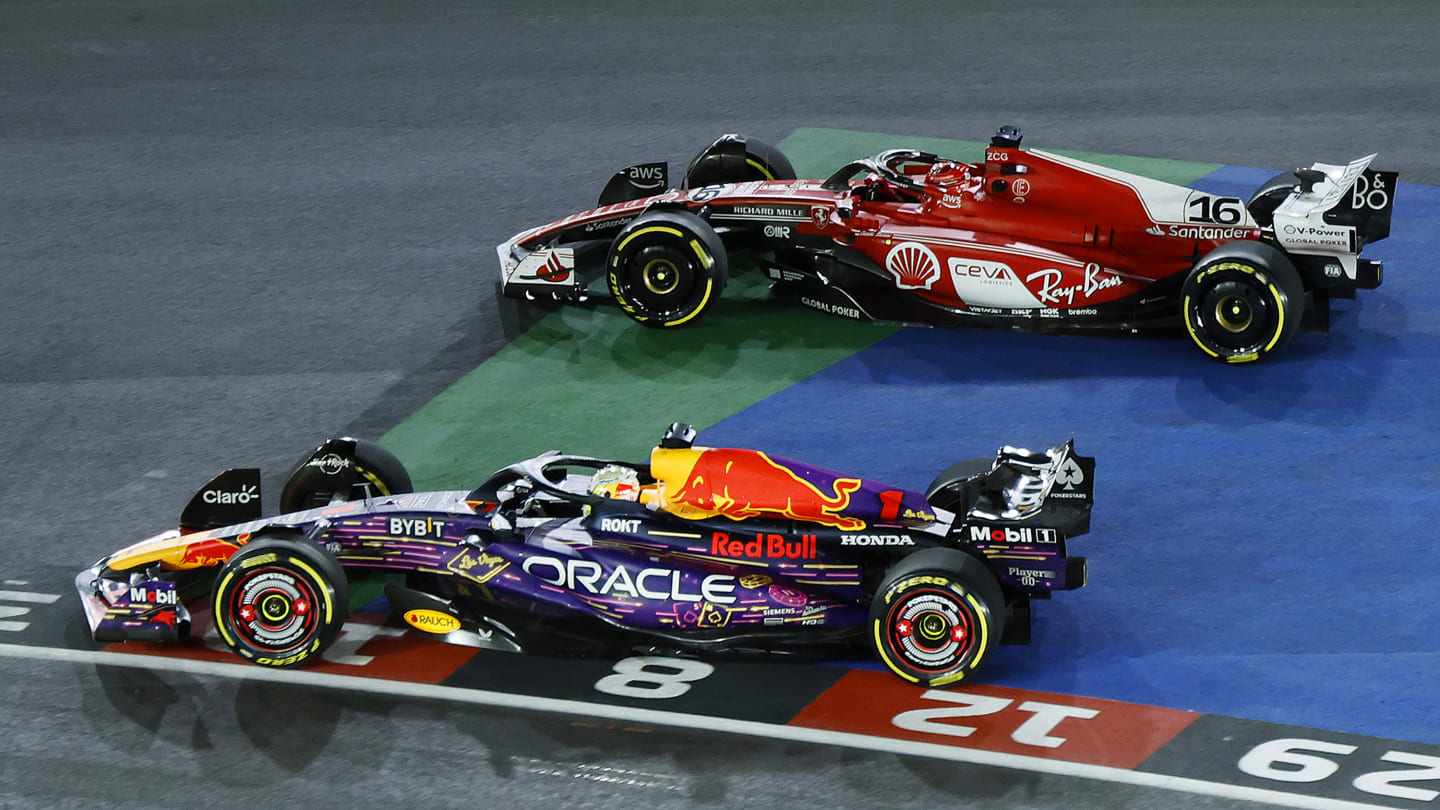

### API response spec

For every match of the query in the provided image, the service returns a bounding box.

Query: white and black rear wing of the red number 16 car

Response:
[1274,154,1400,255]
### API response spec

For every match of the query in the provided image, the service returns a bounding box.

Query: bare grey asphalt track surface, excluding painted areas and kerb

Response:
[0,1,1440,807]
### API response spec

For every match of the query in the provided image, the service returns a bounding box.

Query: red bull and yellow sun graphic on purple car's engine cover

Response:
[651,448,865,530]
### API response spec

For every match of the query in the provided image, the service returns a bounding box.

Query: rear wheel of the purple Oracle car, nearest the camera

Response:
[870,548,1005,687]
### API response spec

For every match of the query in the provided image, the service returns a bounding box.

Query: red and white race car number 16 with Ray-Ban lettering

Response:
[497,127,1397,363]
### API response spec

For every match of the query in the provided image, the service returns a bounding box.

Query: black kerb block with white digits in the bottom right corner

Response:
[1138,715,1440,807]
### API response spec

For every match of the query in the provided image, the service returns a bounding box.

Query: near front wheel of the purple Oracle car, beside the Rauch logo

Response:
[213,535,350,667]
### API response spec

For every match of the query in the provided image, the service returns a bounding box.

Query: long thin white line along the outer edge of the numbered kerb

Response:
[0,644,1385,810]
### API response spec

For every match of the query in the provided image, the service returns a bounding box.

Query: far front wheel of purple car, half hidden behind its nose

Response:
[279,438,415,513]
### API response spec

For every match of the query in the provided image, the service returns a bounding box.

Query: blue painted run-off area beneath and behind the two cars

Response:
[703,167,1440,744]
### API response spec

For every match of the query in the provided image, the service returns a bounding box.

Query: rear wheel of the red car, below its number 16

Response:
[1181,242,1305,363]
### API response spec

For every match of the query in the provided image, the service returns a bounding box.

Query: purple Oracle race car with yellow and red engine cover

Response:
[75,424,1094,686]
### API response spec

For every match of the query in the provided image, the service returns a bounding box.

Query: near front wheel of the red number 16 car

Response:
[606,210,729,327]
